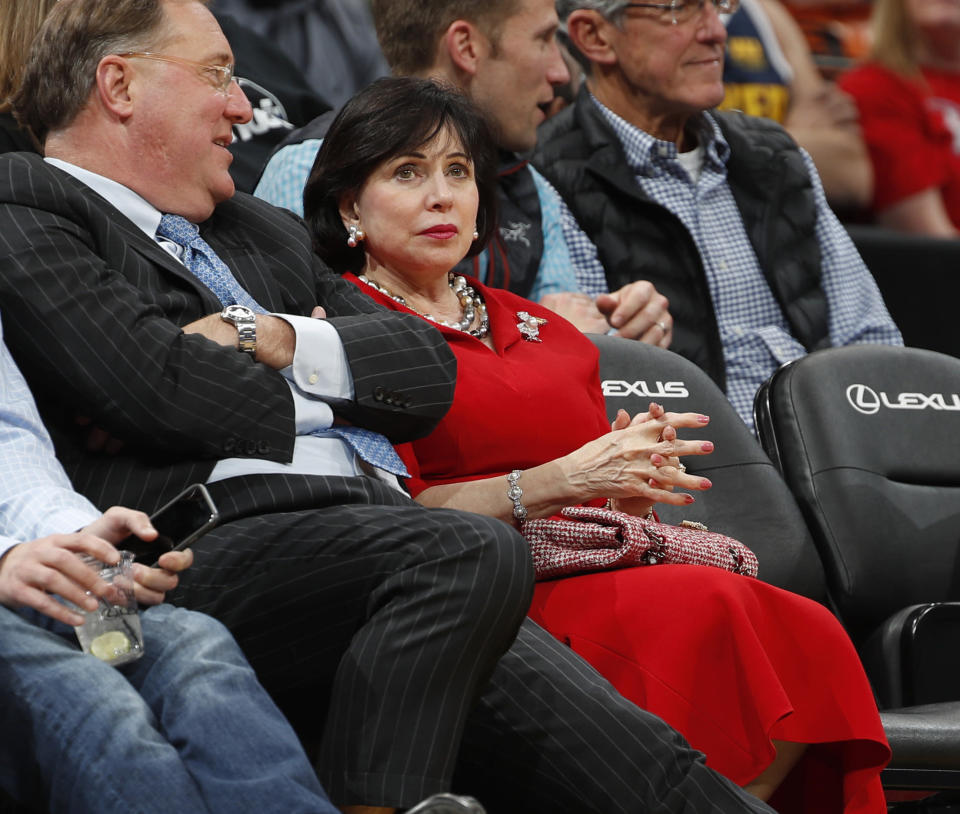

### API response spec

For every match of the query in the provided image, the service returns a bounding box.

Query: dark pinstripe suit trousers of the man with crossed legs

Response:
[171,478,769,814]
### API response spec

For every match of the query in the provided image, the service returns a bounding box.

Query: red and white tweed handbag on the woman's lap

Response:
[520,506,757,579]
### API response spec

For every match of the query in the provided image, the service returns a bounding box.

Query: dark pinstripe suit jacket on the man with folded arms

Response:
[0,153,456,510]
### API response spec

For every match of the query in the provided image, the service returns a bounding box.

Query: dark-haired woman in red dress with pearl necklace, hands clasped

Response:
[304,79,889,814]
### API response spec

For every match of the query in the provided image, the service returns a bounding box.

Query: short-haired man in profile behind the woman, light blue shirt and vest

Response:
[254,0,671,347]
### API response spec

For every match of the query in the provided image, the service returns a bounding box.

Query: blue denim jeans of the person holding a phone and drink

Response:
[0,605,336,814]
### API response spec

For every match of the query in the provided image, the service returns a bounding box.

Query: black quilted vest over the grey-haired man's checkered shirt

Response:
[533,89,830,389]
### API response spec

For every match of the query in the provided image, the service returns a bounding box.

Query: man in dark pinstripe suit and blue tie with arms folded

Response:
[0,0,769,814]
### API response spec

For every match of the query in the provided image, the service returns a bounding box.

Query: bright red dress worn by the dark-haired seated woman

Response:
[348,275,890,814]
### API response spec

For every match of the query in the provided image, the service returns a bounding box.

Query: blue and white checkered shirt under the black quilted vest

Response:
[561,92,903,428]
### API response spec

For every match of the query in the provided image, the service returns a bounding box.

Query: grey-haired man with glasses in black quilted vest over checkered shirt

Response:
[534,0,902,434]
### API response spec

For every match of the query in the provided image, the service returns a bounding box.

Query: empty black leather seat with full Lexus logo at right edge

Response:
[755,345,960,788]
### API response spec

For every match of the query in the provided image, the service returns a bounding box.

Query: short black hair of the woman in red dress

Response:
[303,76,498,273]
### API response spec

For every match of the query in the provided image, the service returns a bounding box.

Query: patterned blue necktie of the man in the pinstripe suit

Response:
[157,215,410,478]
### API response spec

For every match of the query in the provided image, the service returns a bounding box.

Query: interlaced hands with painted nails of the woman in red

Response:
[557,403,713,514]
